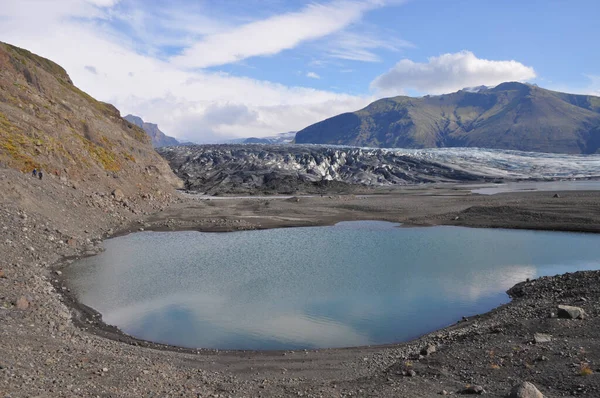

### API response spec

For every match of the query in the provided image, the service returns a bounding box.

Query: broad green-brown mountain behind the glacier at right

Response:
[296,82,600,154]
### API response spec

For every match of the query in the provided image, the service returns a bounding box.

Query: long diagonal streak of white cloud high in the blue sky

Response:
[172,0,383,68]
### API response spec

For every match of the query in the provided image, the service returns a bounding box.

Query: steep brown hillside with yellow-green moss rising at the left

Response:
[0,43,181,196]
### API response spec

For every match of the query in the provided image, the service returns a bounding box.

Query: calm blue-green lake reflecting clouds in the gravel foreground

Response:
[65,221,600,350]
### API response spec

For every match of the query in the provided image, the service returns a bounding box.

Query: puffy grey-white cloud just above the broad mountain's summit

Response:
[371,51,536,95]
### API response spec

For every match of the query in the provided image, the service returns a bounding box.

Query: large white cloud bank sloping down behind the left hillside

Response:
[0,0,374,142]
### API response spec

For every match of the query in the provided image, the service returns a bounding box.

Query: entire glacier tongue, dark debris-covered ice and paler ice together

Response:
[158,145,600,193]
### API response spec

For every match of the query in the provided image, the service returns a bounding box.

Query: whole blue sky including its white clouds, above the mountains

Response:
[0,0,600,142]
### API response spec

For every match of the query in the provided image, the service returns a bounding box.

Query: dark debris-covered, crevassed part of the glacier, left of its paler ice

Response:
[158,145,485,194]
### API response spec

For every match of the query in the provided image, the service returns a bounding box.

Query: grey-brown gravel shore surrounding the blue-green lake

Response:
[0,176,600,397]
